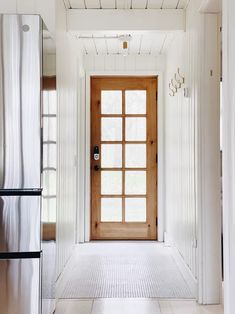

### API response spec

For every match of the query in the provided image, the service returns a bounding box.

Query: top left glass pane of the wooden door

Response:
[101,90,122,114]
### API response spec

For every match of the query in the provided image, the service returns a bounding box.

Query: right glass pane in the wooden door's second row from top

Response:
[126,118,146,141]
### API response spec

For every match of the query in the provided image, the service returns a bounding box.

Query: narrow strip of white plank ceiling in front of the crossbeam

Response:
[67,0,189,9]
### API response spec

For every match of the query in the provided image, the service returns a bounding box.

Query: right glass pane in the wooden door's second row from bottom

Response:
[125,171,146,195]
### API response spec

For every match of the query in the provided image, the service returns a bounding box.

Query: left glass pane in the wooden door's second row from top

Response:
[101,118,122,141]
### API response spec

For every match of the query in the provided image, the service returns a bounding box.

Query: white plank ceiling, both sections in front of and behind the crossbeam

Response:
[66,0,187,55]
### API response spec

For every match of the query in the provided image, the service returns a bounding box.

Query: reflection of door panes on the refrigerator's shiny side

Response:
[42,90,56,223]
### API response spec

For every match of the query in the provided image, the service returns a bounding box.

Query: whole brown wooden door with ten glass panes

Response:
[91,77,157,240]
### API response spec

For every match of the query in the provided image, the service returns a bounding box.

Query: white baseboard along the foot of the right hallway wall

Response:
[164,232,198,299]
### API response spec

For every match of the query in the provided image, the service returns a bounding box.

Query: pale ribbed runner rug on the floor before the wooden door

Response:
[59,241,194,299]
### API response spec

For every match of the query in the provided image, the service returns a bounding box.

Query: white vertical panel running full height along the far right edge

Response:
[222,0,235,314]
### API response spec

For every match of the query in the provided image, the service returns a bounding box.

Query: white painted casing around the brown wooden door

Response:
[77,71,165,243]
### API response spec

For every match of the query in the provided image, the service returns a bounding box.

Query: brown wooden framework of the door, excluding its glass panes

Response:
[90,76,157,240]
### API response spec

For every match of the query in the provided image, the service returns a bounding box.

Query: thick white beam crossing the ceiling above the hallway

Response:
[67,9,185,34]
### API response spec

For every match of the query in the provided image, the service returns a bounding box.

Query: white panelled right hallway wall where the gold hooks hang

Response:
[165,34,197,278]
